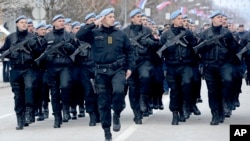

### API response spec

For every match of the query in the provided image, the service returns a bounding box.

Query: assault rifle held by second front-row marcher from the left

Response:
[35,41,65,65]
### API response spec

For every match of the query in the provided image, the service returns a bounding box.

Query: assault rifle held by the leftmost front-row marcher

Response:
[1,39,31,59]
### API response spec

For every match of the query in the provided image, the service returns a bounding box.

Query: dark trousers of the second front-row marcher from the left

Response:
[47,66,72,114]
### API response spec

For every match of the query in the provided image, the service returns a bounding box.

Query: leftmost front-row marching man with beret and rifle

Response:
[0,15,40,130]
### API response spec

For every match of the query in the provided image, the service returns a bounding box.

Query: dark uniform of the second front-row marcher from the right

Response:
[161,26,197,125]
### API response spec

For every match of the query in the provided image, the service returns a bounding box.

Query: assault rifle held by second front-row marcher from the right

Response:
[156,31,187,57]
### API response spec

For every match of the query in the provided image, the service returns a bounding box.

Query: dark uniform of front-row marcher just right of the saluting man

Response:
[123,24,158,121]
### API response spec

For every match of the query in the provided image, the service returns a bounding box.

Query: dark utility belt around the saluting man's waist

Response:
[95,58,125,73]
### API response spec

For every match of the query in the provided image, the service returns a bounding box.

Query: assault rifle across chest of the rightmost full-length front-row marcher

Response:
[193,33,227,54]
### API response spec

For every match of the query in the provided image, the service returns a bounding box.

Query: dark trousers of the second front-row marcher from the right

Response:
[167,65,193,111]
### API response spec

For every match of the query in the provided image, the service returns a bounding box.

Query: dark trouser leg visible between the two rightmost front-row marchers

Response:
[191,65,201,105]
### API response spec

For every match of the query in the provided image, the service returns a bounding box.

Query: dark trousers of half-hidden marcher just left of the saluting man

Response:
[80,66,98,113]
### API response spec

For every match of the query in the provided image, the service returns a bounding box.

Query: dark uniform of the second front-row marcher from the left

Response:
[44,28,75,128]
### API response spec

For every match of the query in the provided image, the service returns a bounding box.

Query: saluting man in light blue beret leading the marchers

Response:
[76,8,134,141]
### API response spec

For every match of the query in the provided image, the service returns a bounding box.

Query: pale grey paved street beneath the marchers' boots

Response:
[0,63,250,141]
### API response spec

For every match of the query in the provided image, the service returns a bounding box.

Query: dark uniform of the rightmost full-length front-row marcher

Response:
[199,26,240,125]
